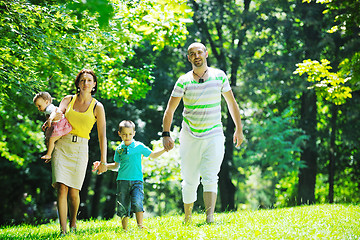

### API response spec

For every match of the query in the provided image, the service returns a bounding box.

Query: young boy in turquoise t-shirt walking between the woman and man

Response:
[93,120,165,230]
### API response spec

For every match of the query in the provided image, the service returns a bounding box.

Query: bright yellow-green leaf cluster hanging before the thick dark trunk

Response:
[294,59,352,105]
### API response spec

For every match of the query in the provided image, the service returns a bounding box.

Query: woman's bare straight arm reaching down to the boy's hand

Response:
[94,102,107,173]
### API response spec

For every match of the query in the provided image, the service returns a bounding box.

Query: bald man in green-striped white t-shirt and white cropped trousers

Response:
[162,42,244,223]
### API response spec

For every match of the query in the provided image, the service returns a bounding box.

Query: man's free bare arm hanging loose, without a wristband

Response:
[223,90,244,147]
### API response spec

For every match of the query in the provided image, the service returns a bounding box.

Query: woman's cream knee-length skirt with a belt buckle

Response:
[51,134,89,190]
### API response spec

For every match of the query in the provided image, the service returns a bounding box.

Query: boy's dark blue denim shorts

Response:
[116,180,144,217]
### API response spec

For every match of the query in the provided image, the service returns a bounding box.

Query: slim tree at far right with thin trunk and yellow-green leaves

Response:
[294,0,360,203]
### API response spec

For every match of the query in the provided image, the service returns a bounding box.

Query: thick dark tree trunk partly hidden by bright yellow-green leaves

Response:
[297,3,324,204]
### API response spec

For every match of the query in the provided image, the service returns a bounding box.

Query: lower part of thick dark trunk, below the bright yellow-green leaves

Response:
[297,92,317,205]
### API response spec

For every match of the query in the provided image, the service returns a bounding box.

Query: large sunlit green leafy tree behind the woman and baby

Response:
[0,0,191,223]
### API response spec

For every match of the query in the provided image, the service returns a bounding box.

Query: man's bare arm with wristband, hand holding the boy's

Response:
[163,97,181,151]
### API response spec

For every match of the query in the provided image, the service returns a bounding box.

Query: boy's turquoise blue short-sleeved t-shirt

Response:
[114,140,152,181]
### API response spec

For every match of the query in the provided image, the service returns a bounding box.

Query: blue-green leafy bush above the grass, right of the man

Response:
[234,110,307,209]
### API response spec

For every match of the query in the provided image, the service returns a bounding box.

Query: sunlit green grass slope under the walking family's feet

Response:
[0,204,360,240]
